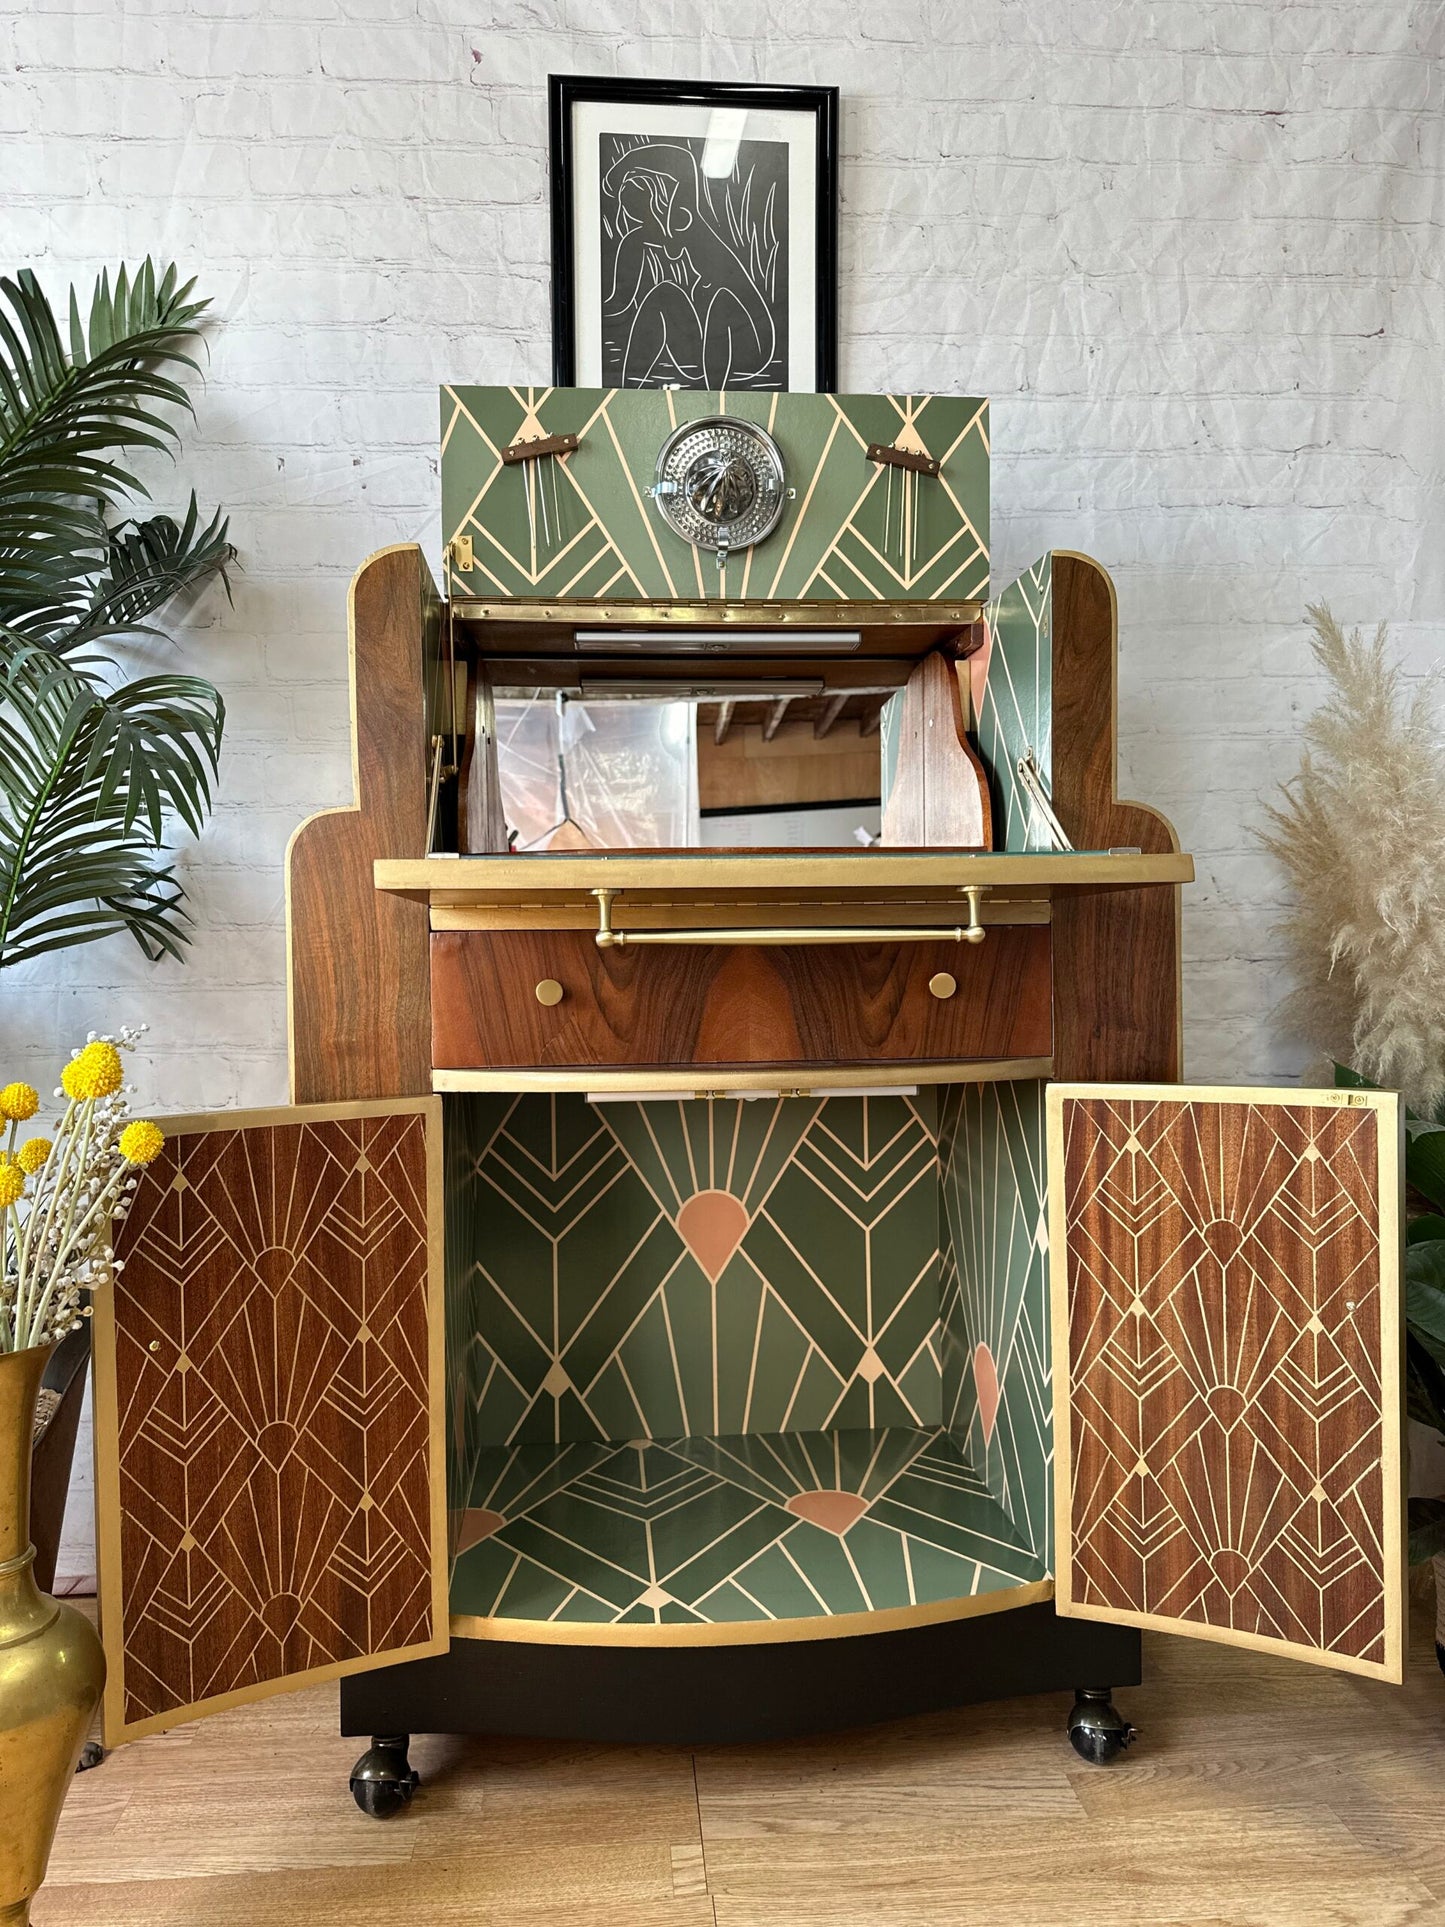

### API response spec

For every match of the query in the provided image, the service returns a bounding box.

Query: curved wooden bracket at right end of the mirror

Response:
[882,649,994,850]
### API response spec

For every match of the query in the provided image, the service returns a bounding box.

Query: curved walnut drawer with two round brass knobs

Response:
[432,925,1052,1069]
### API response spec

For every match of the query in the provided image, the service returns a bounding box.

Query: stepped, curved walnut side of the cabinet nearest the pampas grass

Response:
[1052,549,1183,1083]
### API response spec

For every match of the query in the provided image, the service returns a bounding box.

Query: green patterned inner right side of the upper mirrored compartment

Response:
[969,555,1054,850]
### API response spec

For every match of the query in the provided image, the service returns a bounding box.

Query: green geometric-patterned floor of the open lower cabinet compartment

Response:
[451,1428,1044,1626]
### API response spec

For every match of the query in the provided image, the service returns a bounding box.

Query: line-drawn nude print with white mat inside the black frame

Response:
[572,100,817,389]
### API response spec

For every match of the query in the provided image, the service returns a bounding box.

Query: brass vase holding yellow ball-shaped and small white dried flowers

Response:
[0,1033,164,1921]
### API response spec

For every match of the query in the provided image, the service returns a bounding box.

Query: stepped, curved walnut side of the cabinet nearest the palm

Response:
[285,543,441,1104]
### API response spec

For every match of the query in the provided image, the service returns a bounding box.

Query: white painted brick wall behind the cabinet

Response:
[0,0,1445,1572]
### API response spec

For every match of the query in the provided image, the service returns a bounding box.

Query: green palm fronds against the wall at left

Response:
[0,260,235,967]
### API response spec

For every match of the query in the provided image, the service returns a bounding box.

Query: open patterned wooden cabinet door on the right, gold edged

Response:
[1048,1085,1405,1680]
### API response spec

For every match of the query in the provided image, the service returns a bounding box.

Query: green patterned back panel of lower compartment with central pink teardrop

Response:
[447,1093,942,1465]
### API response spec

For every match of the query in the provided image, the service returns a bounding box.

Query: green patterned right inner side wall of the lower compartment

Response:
[938,1079,1054,1561]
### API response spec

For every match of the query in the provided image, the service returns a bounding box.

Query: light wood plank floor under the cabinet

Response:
[35,1619,1445,1927]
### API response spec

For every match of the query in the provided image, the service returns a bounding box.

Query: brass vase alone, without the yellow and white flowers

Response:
[0,1345,106,1927]
